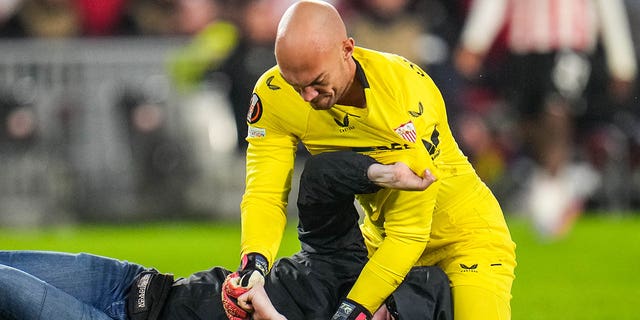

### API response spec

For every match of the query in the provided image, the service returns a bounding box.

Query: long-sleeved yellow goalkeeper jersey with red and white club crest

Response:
[241,47,475,311]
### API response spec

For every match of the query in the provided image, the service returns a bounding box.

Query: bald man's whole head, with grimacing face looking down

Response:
[275,0,364,110]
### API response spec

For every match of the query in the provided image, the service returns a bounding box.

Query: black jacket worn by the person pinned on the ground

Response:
[131,151,452,320]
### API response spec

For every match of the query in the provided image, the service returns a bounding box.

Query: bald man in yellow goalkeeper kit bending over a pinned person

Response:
[225,1,516,319]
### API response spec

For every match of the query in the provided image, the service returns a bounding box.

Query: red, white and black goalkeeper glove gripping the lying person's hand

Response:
[221,253,269,320]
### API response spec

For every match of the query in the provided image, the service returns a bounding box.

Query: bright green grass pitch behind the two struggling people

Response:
[0,215,640,320]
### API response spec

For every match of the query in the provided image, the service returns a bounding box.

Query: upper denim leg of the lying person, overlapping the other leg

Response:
[0,251,145,319]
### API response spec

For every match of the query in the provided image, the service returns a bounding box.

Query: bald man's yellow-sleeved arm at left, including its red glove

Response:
[222,80,298,318]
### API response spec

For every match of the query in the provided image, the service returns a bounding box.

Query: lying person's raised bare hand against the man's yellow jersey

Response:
[367,162,436,191]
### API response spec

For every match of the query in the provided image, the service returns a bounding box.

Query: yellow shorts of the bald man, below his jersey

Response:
[418,175,516,320]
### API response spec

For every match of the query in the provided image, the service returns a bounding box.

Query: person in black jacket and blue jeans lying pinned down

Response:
[0,152,452,320]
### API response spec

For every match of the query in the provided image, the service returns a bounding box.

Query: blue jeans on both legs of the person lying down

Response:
[0,251,146,320]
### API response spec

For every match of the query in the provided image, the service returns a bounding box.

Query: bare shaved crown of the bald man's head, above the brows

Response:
[275,0,347,69]
